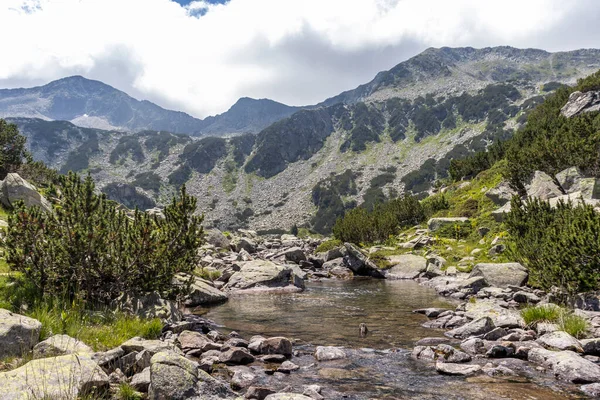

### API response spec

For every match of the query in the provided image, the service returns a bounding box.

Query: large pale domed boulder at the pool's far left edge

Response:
[224,260,298,291]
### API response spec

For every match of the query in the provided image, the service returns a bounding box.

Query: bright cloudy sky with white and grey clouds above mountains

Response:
[0,0,600,117]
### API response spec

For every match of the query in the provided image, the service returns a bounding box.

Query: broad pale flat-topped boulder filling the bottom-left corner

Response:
[0,354,109,400]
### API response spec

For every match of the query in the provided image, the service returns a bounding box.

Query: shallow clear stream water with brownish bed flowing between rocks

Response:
[200,279,579,400]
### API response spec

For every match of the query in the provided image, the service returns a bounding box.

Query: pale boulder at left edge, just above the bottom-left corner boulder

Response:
[0,308,42,358]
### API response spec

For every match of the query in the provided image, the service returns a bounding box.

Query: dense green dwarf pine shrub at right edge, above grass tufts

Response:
[505,196,600,295]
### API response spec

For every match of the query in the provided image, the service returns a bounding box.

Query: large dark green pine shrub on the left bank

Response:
[6,173,203,303]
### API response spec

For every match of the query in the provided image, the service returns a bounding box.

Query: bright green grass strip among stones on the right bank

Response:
[521,305,590,339]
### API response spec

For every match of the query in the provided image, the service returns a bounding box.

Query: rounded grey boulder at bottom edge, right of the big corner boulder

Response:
[148,351,198,400]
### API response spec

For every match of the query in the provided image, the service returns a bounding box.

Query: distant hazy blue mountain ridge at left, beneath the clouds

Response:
[0,76,297,136]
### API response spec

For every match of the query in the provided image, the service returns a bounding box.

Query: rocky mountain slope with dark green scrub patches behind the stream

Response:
[8,47,600,233]
